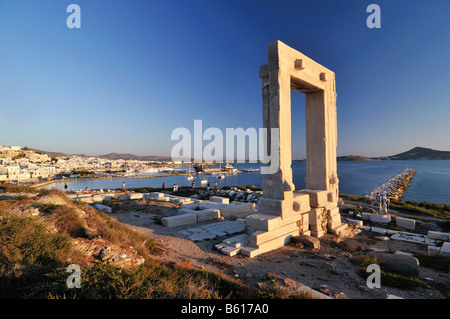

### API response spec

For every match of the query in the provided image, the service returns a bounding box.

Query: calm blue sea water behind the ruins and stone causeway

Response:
[50,160,450,204]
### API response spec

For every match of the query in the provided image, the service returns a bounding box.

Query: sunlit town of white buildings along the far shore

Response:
[0,145,169,184]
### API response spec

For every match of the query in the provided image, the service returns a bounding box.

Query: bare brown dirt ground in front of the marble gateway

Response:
[110,200,450,299]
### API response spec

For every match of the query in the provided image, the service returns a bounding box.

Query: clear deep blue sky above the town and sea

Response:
[0,0,450,158]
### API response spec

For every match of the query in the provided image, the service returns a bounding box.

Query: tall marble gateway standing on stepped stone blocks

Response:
[241,41,346,257]
